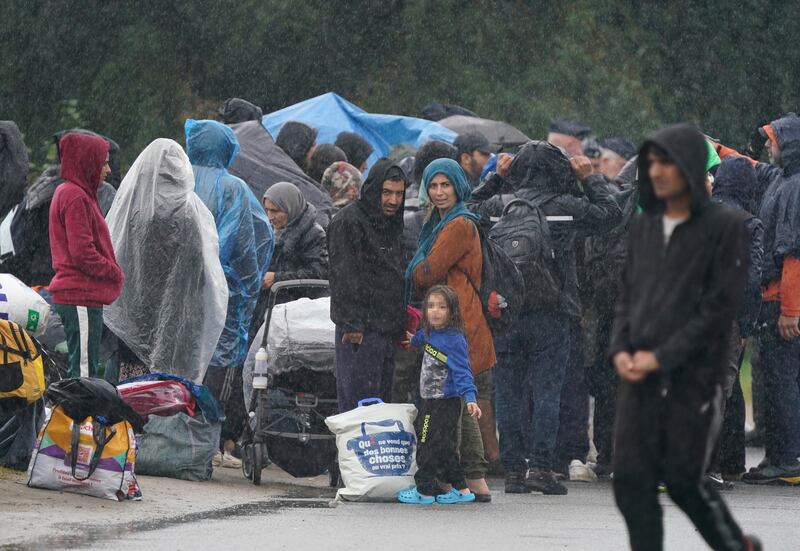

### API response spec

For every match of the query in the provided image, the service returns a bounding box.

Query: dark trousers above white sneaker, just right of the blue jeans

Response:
[554,321,589,472]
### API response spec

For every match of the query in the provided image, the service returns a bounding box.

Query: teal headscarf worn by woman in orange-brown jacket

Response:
[406,159,480,302]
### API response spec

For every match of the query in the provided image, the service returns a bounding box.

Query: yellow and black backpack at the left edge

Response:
[0,319,45,409]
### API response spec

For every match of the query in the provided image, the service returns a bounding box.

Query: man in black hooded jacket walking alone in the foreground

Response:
[610,125,760,551]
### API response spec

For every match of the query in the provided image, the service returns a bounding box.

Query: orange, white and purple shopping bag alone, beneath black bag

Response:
[28,404,138,500]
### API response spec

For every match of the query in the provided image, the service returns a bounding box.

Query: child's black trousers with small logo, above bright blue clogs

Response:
[414,398,467,495]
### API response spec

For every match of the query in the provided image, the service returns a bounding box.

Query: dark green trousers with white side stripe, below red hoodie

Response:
[53,304,105,377]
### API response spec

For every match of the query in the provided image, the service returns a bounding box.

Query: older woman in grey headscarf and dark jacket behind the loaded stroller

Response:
[250,182,328,340]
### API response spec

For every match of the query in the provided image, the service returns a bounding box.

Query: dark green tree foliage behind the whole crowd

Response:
[0,0,800,168]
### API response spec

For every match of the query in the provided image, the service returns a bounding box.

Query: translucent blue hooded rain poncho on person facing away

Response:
[186,119,274,368]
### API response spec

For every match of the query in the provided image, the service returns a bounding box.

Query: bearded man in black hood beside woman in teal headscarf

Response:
[328,159,407,412]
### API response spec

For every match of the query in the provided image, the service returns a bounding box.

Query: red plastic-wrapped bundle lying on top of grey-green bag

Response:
[117,381,195,420]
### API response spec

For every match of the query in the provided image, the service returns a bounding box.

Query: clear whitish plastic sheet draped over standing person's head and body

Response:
[103,138,228,383]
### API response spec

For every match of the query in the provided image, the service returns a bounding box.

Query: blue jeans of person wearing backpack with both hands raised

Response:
[494,311,570,472]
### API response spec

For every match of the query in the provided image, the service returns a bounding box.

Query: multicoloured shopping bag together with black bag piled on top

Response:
[28,378,142,500]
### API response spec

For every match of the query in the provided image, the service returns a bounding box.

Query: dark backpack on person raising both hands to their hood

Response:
[490,197,561,309]
